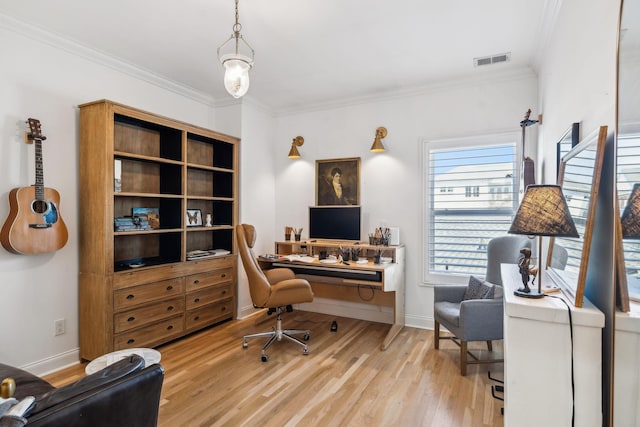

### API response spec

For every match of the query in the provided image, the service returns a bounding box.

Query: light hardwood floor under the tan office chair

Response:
[46,311,503,427]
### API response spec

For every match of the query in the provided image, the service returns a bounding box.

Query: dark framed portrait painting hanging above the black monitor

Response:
[315,157,360,206]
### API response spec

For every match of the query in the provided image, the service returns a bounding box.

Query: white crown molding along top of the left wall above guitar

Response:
[0,13,215,107]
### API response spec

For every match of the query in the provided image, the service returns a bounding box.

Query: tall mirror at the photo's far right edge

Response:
[613,0,640,426]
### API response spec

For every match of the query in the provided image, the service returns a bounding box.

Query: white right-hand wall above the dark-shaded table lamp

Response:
[538,0,620,183]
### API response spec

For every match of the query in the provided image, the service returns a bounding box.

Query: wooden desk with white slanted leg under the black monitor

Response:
[260,242,405,350]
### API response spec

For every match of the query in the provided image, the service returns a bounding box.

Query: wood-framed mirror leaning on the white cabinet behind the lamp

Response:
[547,126,607,307]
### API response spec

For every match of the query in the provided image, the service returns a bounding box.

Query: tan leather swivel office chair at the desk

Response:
[236,224,313,362]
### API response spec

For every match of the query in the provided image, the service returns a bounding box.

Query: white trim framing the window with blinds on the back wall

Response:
[420,131,522,287]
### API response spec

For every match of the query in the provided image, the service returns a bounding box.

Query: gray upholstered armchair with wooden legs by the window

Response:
[433,235,531,375]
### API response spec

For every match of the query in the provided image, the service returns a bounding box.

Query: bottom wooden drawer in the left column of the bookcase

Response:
[113,313,184,350]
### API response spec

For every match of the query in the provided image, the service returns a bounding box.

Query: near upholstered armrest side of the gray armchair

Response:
[460,298,504,341]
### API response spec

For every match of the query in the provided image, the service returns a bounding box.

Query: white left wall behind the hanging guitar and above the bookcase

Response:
[0,20,214,372]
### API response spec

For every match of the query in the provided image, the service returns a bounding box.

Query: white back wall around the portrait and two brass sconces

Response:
[274,72,537,327]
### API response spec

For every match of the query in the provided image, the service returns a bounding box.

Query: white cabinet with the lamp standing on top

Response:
[501,264,604,427]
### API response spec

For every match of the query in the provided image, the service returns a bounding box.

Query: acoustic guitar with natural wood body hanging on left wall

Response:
[0,118,69,255]
